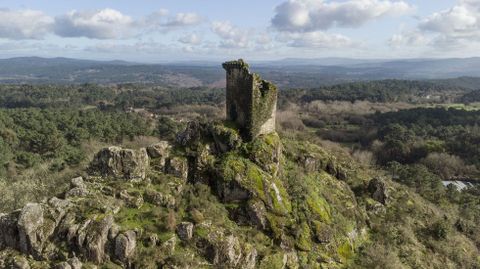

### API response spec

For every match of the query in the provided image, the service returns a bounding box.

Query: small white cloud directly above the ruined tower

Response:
[212,21,254,49]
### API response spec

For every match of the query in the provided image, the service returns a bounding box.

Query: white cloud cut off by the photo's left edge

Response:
[0,9,54,39]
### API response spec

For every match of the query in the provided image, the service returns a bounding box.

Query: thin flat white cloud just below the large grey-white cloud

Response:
[279,31,355,48]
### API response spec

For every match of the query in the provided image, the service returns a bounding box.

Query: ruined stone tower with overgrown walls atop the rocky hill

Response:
[222,59,277,140]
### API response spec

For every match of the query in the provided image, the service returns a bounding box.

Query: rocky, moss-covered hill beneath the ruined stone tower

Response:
[0,60,479,269]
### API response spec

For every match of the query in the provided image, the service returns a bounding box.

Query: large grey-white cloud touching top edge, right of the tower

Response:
[271,0,414,32]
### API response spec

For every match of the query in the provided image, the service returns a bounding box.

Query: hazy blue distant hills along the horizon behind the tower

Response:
[0,57,480,89]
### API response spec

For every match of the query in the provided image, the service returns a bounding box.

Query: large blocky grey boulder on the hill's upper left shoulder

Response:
[89,146,149,180]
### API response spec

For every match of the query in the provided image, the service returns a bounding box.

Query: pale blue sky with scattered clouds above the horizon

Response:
[0,0,480,63]
